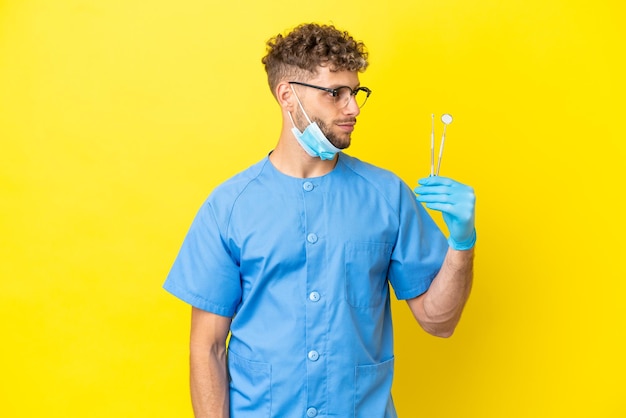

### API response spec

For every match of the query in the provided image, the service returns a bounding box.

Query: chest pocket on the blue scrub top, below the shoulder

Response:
[344,242,393,308]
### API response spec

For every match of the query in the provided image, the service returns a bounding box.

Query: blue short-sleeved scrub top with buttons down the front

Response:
[164,153,448,418]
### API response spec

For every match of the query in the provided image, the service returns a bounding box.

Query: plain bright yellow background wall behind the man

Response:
[0,0,626,418]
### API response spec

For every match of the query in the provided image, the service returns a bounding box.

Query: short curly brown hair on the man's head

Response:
[261,23,369,94]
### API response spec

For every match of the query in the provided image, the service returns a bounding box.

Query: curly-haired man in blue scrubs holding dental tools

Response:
[164,24,476,418]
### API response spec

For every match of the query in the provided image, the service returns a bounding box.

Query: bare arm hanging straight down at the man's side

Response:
[189,308,231,418]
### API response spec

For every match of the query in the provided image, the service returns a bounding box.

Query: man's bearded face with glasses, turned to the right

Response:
[293,67,360,149]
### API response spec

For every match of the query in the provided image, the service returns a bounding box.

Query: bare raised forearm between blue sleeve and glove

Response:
[407,248,474,337]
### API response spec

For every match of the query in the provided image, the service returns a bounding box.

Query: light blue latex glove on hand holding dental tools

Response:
[414,176,476,251]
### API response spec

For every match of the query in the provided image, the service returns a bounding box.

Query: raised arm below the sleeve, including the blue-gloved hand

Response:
[407,176,476,337]
